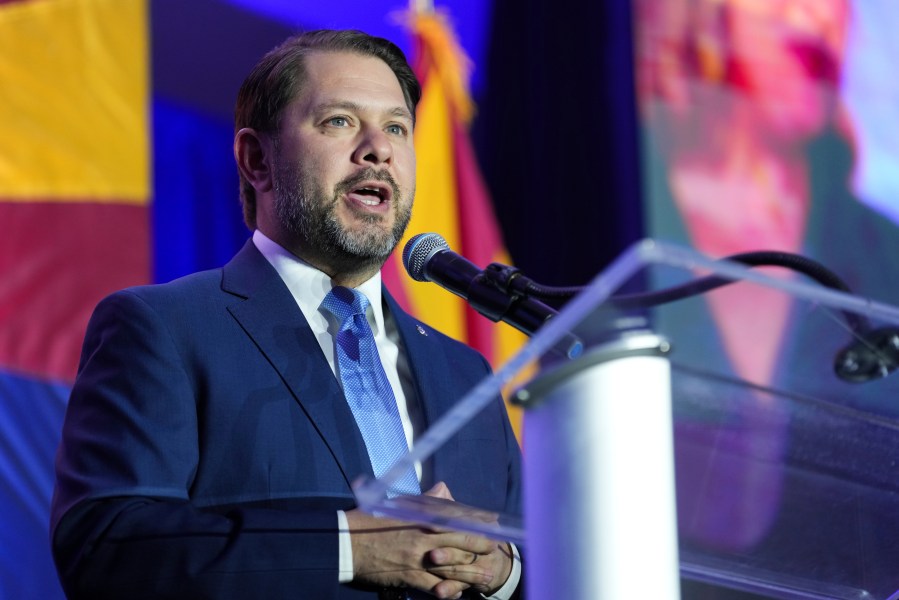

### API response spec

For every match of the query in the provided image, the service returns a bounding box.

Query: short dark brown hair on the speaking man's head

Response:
[234,29,421,230]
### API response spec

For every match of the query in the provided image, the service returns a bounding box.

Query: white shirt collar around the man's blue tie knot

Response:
[253,229,384,335]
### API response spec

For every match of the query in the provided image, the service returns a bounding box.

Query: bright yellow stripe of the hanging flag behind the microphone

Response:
[400,69,466,341]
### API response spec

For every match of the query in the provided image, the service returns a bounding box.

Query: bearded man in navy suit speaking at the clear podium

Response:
[51,31,523,599]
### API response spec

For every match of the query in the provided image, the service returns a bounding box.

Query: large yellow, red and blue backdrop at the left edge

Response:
[0,0,150,598]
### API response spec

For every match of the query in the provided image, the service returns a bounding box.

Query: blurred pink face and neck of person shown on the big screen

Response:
[636,0,852,398]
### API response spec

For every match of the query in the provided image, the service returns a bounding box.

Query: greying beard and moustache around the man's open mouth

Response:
[273,164,412,267]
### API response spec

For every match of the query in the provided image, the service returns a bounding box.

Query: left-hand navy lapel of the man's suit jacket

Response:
[222,240,374,485]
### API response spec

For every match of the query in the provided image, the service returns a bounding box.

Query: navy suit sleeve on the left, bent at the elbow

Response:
[51,292,352,599]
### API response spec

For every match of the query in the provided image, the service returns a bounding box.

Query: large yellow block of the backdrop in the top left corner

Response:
[0,0,150,204]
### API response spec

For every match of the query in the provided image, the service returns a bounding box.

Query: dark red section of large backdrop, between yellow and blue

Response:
[0,201,150,381]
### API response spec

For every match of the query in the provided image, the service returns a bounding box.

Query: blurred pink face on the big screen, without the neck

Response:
[637,0,849,148]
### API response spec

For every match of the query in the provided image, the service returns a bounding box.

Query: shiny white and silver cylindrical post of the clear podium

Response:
[517,333,680,600]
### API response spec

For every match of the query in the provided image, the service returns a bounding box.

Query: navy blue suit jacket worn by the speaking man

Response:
[51,242,520,599]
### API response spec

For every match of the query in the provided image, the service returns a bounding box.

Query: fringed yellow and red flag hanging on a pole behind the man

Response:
[384,11,525,431]
